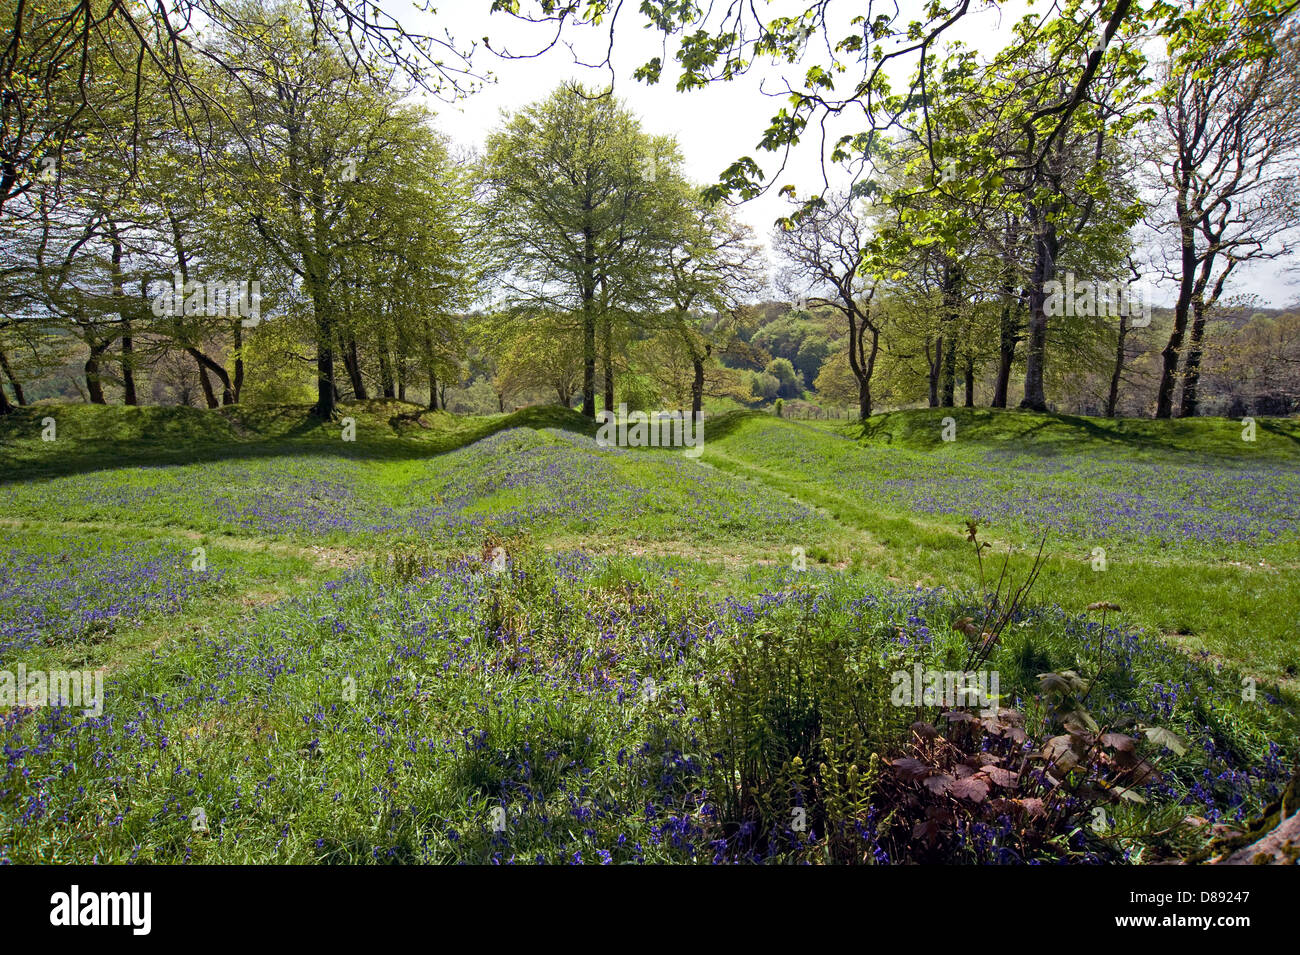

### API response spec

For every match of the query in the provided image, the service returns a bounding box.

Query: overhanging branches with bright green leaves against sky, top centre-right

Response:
[493,0,1154,216]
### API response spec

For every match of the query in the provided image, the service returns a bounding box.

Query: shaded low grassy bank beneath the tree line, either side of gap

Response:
[0,399,1300,485]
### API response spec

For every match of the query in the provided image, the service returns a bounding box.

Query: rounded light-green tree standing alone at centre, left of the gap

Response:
[482,83,680,417]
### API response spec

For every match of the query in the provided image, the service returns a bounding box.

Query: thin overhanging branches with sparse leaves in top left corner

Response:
[0,0,478,214]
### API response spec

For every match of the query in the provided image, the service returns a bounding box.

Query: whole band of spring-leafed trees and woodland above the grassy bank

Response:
[0,0,1300,417]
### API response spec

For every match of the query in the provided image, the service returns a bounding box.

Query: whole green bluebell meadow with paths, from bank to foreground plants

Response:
[0,401,1300,863]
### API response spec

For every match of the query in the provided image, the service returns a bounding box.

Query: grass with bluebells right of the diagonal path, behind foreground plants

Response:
[705,409,1300,681]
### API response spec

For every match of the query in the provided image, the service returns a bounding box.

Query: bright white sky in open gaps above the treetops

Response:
[400,0,1297,307]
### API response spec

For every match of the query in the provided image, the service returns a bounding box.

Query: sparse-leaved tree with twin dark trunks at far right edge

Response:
[1145,0,1300,418]
